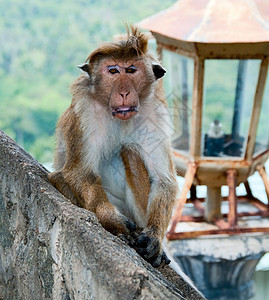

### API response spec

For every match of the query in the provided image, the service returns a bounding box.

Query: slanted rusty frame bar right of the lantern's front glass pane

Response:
[245,59,268,161]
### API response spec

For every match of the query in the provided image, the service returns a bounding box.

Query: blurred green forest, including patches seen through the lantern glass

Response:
[0,0,269,163]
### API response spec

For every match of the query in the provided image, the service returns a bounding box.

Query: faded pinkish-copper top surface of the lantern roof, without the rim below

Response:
[138,0,269,43]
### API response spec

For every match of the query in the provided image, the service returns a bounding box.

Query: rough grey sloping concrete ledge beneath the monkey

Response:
[0,131,203,300]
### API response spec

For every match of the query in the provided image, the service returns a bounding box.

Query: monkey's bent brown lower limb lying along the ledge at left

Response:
[49,168,136,235]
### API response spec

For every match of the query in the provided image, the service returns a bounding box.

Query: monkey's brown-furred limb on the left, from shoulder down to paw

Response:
[49,106,136,234]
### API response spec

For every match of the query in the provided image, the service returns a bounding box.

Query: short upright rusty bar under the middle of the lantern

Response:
[227,169,237,228]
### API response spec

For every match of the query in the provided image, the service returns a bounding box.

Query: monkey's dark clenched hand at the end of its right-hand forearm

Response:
[134,228,170,268]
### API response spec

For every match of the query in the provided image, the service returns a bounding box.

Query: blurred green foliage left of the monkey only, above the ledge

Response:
[0,0,175,163]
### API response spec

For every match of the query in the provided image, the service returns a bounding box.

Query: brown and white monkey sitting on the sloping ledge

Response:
[49,26,178,267]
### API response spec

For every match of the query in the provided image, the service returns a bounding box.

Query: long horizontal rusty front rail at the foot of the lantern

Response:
[167,227,269,241]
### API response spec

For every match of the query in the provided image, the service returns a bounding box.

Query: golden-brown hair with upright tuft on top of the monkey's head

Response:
[85,25,148,64]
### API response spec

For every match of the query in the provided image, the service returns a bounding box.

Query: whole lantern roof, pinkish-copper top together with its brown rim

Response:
[137,0,269,59]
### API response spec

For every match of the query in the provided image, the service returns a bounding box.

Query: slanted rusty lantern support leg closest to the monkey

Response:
[167,163,197,235]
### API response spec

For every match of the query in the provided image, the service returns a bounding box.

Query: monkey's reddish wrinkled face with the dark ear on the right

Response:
[84,58,165,120]
